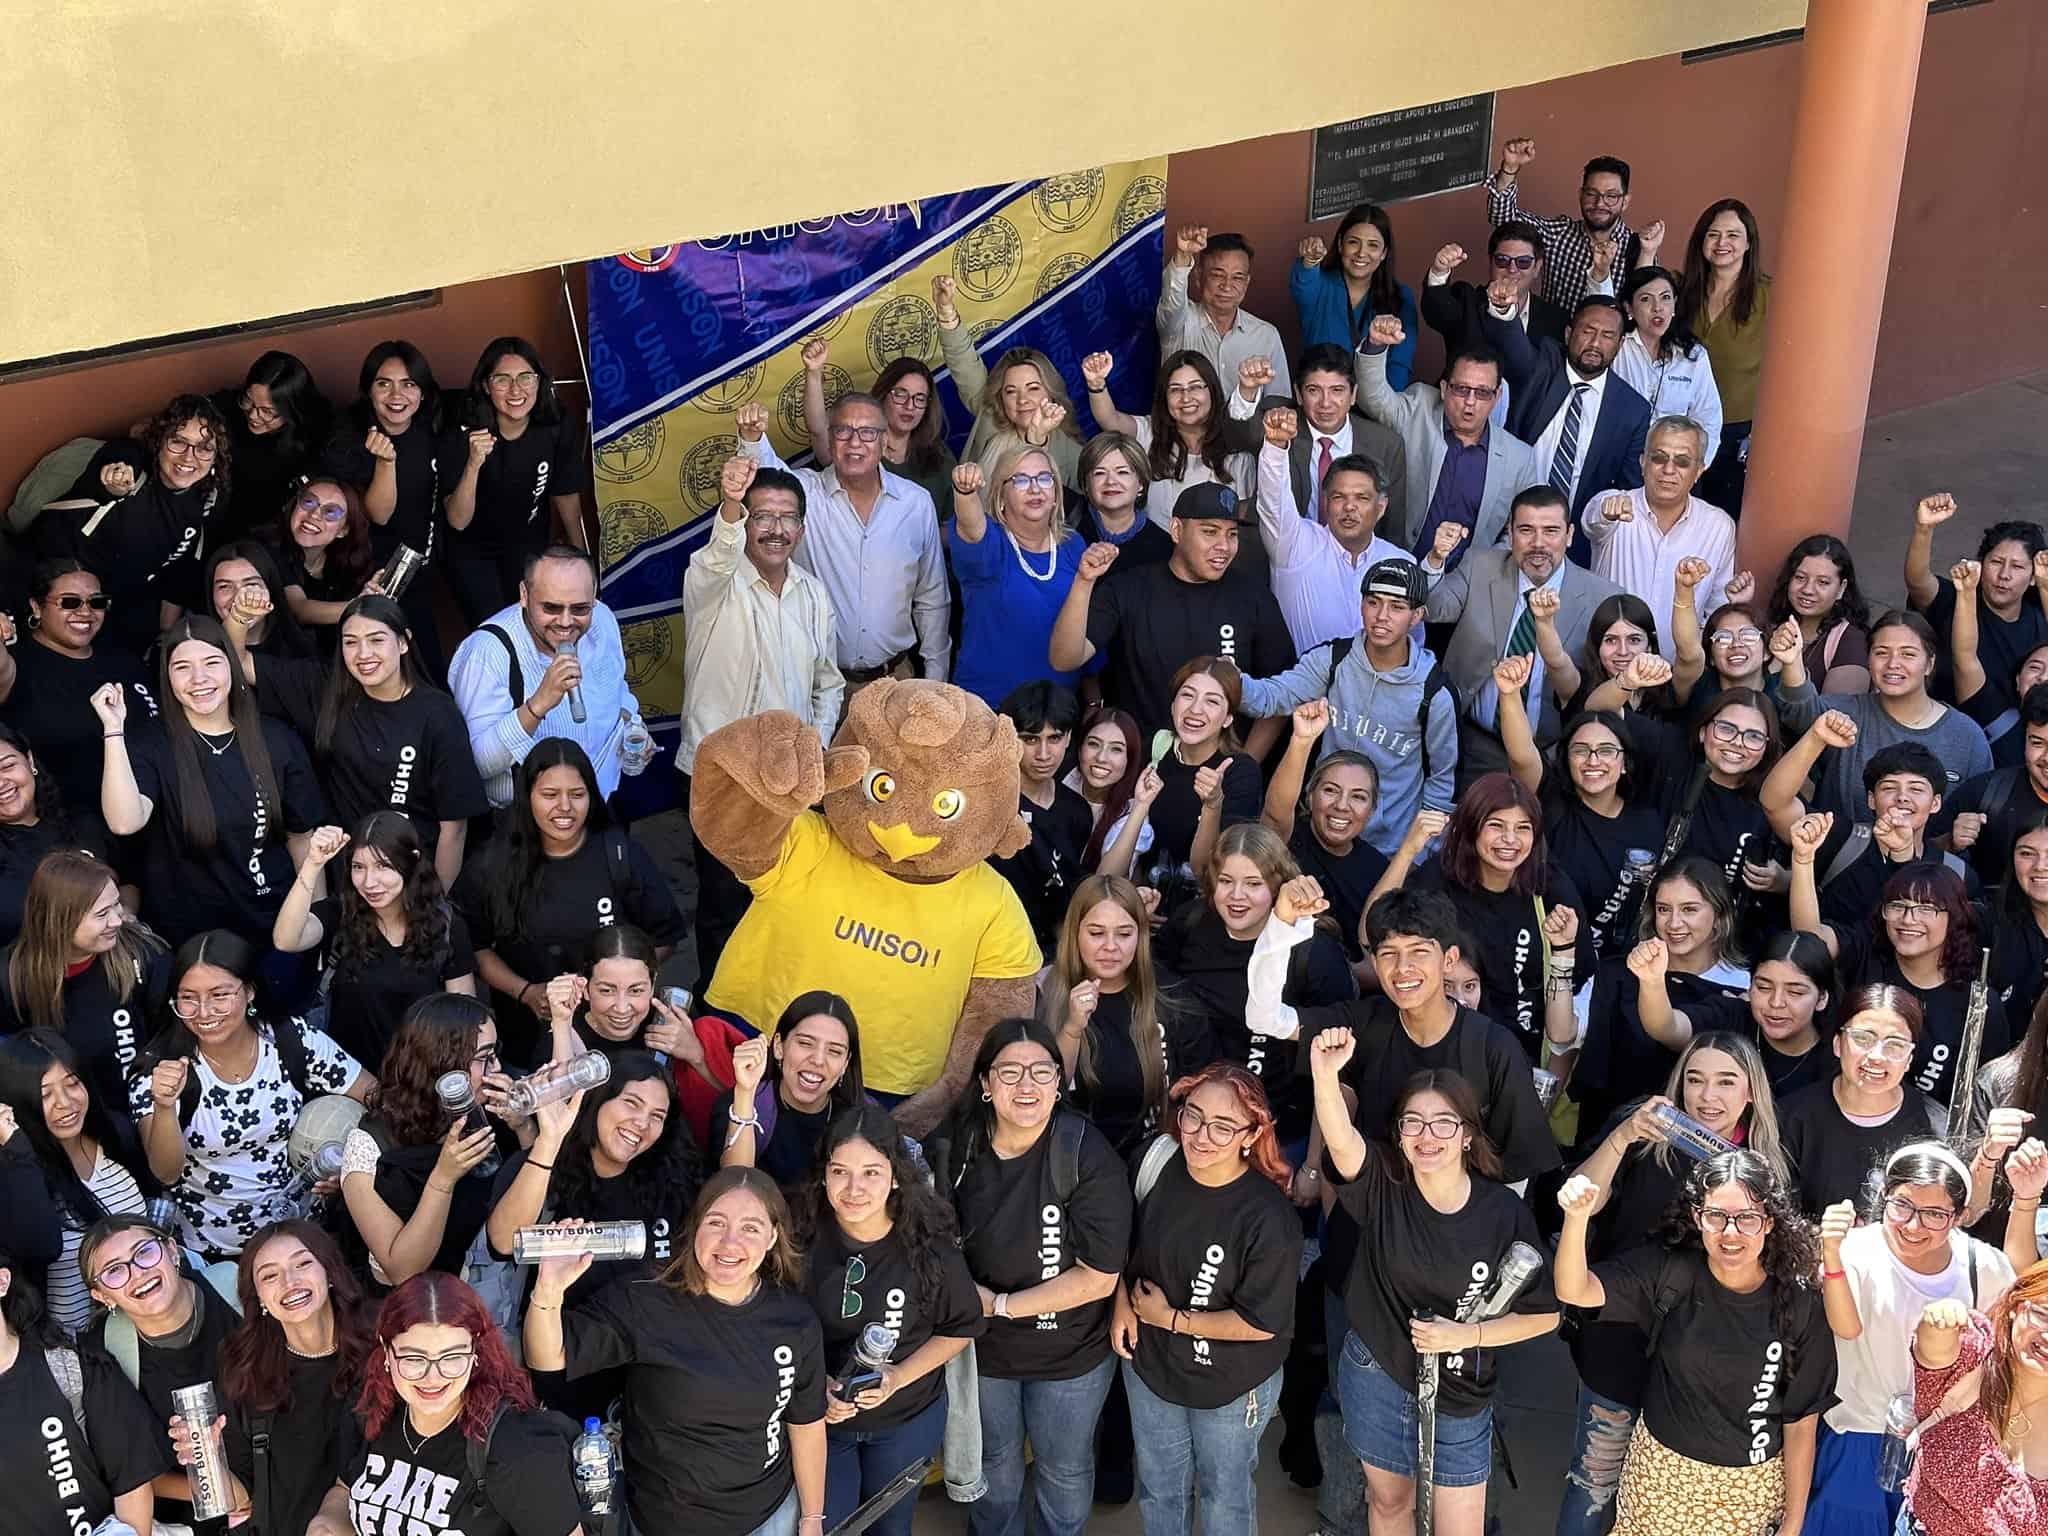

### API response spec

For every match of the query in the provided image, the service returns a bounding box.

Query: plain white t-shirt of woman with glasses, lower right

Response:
[1827,1225,2013,1434]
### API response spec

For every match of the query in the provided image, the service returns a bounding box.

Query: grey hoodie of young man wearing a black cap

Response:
[1245,635,1458,856]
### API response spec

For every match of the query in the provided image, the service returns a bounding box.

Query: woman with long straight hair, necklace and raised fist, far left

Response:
[92,618,326,944]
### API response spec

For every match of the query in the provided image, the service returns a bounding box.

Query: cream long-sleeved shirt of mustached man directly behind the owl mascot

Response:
[676,516,846,774]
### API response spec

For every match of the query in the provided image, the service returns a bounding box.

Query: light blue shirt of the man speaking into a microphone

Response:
[449,602,639,807]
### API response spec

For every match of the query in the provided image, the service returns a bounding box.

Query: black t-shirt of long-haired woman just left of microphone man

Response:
[317,688,489,856]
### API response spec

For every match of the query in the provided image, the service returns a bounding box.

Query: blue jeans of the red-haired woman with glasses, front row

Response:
[1124,1364,1280,1536]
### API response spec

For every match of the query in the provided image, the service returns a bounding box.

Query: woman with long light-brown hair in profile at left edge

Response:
[0,848,164,1106]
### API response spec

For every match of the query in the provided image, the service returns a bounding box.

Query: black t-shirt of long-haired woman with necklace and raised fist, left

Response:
[127,717,326,950]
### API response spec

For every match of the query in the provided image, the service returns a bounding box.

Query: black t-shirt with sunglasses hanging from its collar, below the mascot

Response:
[805,1214,981,1434]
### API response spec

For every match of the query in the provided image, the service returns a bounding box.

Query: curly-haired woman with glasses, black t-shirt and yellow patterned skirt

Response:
[1554,1149,1835,1536]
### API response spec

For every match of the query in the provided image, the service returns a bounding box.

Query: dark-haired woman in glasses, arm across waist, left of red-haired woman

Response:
[933,1024,1130,1536]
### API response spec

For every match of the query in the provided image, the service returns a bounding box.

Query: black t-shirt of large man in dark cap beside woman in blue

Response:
[1087,563,1294,741]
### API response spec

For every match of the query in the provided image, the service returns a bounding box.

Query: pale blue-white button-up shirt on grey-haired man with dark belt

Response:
[739,436,952,682]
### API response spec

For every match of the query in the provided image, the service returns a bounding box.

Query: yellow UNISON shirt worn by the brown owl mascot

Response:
[707,811,1040,1094]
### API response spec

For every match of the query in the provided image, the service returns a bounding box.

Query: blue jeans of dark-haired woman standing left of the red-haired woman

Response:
[967,1354,1116,1536]
